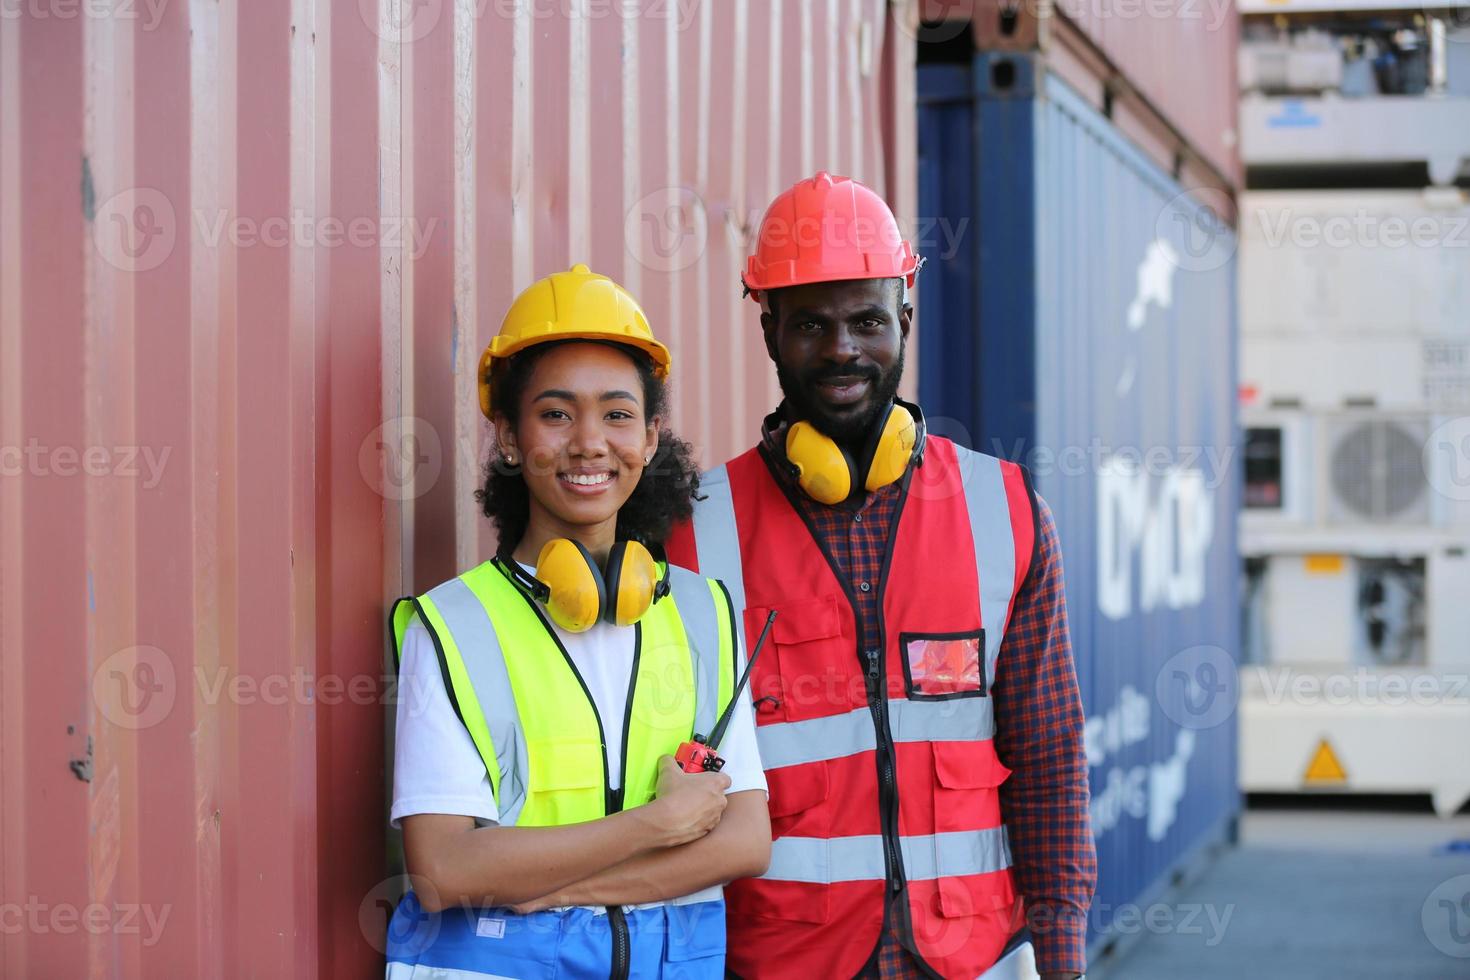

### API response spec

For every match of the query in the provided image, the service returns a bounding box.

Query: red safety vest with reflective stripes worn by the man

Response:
[669,436,1036,980]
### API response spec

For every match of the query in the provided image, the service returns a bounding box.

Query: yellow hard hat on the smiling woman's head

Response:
[479,263,670,419]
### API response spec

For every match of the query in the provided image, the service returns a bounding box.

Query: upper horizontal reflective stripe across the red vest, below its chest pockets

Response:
[756,698,995,771]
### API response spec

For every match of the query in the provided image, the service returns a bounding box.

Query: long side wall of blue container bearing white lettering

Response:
[1035,79,1244,952]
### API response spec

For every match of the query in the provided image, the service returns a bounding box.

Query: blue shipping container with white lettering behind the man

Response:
[919,53,1241,951]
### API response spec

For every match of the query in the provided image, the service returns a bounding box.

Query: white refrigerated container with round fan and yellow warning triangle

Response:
[1241,188,1470,814]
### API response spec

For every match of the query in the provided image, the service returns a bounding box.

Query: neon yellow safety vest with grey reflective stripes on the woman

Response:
[392,561,736,827]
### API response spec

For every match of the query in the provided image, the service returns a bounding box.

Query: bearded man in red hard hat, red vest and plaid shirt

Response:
[669,172,1097,979]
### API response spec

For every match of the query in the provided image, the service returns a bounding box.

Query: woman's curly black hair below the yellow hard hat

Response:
[475,341,700,554]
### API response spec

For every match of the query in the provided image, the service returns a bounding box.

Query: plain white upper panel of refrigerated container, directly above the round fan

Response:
[1239,188,1470,411]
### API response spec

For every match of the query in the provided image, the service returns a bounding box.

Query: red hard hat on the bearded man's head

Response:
[741,170,919,301]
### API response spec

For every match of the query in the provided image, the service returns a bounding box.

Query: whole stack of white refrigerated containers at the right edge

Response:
[1241,0,1470,815]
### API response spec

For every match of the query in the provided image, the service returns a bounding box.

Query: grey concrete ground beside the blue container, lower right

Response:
[1088,810,1470,980]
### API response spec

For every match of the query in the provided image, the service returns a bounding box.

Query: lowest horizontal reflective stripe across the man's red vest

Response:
[761,827,1010,884]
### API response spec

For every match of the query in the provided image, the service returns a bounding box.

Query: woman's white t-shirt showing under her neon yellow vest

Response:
[390,578,766,901]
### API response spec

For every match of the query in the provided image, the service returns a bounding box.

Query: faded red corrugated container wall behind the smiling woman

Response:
[0,0,914,977]
